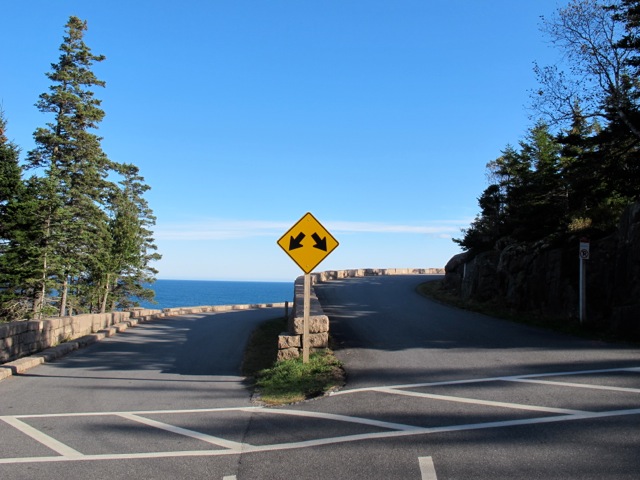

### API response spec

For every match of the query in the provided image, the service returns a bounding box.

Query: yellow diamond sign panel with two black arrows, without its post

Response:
[278,213,338,273]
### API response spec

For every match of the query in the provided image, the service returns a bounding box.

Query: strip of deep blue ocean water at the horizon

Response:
[140,280,293,309]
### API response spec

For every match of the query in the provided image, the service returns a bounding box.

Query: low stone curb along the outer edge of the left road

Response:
[0,302,285,381]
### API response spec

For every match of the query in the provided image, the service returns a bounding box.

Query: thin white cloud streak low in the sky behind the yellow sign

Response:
[154,219,469,241]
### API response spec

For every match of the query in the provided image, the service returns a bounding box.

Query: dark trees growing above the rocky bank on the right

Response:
[455,0,640,255]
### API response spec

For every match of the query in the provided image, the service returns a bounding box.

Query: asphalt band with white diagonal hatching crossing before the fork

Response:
[0,366,640,472]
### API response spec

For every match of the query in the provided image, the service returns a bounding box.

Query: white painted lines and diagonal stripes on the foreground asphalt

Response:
[0,367,640,464]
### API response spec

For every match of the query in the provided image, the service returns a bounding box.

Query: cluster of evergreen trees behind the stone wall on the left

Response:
[0,16,159,319]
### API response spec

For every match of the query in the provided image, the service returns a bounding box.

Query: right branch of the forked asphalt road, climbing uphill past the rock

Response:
[316,276,640,388]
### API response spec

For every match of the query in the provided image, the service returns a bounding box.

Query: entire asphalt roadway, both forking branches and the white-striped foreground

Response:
[0,276,640,480]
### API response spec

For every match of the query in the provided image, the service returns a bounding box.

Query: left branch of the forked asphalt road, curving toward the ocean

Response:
[0,308,284,416]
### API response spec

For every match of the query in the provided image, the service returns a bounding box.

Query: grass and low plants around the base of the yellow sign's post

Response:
[242,318,344,405]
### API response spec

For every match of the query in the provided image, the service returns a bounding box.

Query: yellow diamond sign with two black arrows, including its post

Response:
[277,213,338,363]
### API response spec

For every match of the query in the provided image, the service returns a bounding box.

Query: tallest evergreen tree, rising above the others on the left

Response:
[27,17,114,315]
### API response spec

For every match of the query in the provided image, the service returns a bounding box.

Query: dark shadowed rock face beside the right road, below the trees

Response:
[444,203,640,338]
